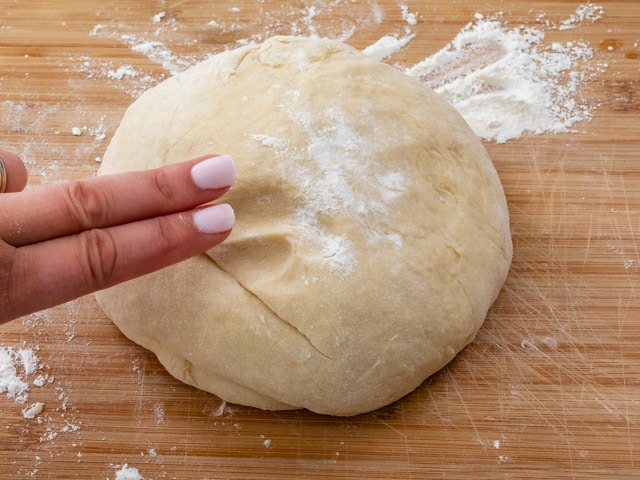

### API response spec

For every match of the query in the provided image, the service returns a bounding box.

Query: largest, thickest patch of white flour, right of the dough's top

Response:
[406,6,604,143]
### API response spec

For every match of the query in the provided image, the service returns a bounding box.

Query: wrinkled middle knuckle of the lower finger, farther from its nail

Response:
[79,229,118,288]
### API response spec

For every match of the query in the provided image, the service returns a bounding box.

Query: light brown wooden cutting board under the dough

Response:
[0,0,640,480]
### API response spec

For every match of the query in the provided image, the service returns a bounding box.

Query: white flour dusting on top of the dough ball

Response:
[248,87,406,275]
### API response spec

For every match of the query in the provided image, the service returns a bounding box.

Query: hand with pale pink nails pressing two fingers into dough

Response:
[0,150,235,324]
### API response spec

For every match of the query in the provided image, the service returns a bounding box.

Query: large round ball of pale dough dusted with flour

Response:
[96,37,512,415]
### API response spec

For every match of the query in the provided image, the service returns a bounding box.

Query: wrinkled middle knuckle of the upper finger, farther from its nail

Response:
[65,181,109,230]
